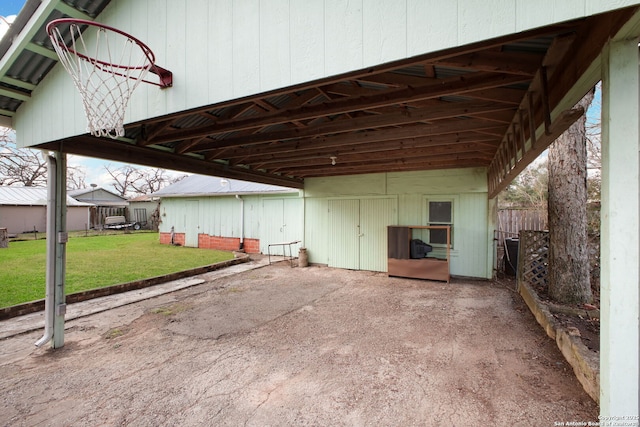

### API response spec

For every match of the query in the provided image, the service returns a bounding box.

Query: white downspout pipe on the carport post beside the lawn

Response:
[35,155,58,347]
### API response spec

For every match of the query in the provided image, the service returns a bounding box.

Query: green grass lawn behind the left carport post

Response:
[0,232,233,307]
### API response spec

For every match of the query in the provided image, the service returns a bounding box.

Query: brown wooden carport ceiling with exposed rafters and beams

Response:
[3,5,635,191]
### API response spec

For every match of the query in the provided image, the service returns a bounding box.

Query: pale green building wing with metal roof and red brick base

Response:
[153,175,304,253]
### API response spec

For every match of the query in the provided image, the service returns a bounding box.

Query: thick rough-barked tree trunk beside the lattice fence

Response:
[548,90,594,304]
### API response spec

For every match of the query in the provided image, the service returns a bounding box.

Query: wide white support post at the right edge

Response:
[600,38,640,418]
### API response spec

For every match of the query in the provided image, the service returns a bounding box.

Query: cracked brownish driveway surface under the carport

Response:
[0,262,598,426]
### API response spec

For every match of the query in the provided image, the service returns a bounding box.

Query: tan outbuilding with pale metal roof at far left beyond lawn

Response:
[0,186,91,235]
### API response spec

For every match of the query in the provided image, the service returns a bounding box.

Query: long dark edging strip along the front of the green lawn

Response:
[0,253,251,320]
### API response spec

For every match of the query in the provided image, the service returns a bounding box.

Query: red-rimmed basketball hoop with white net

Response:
[47,18,173,138]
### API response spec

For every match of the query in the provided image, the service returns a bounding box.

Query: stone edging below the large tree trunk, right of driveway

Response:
[518,283,600,403]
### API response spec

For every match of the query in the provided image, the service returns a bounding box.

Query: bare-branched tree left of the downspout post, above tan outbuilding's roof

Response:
[0,128,47,187]
